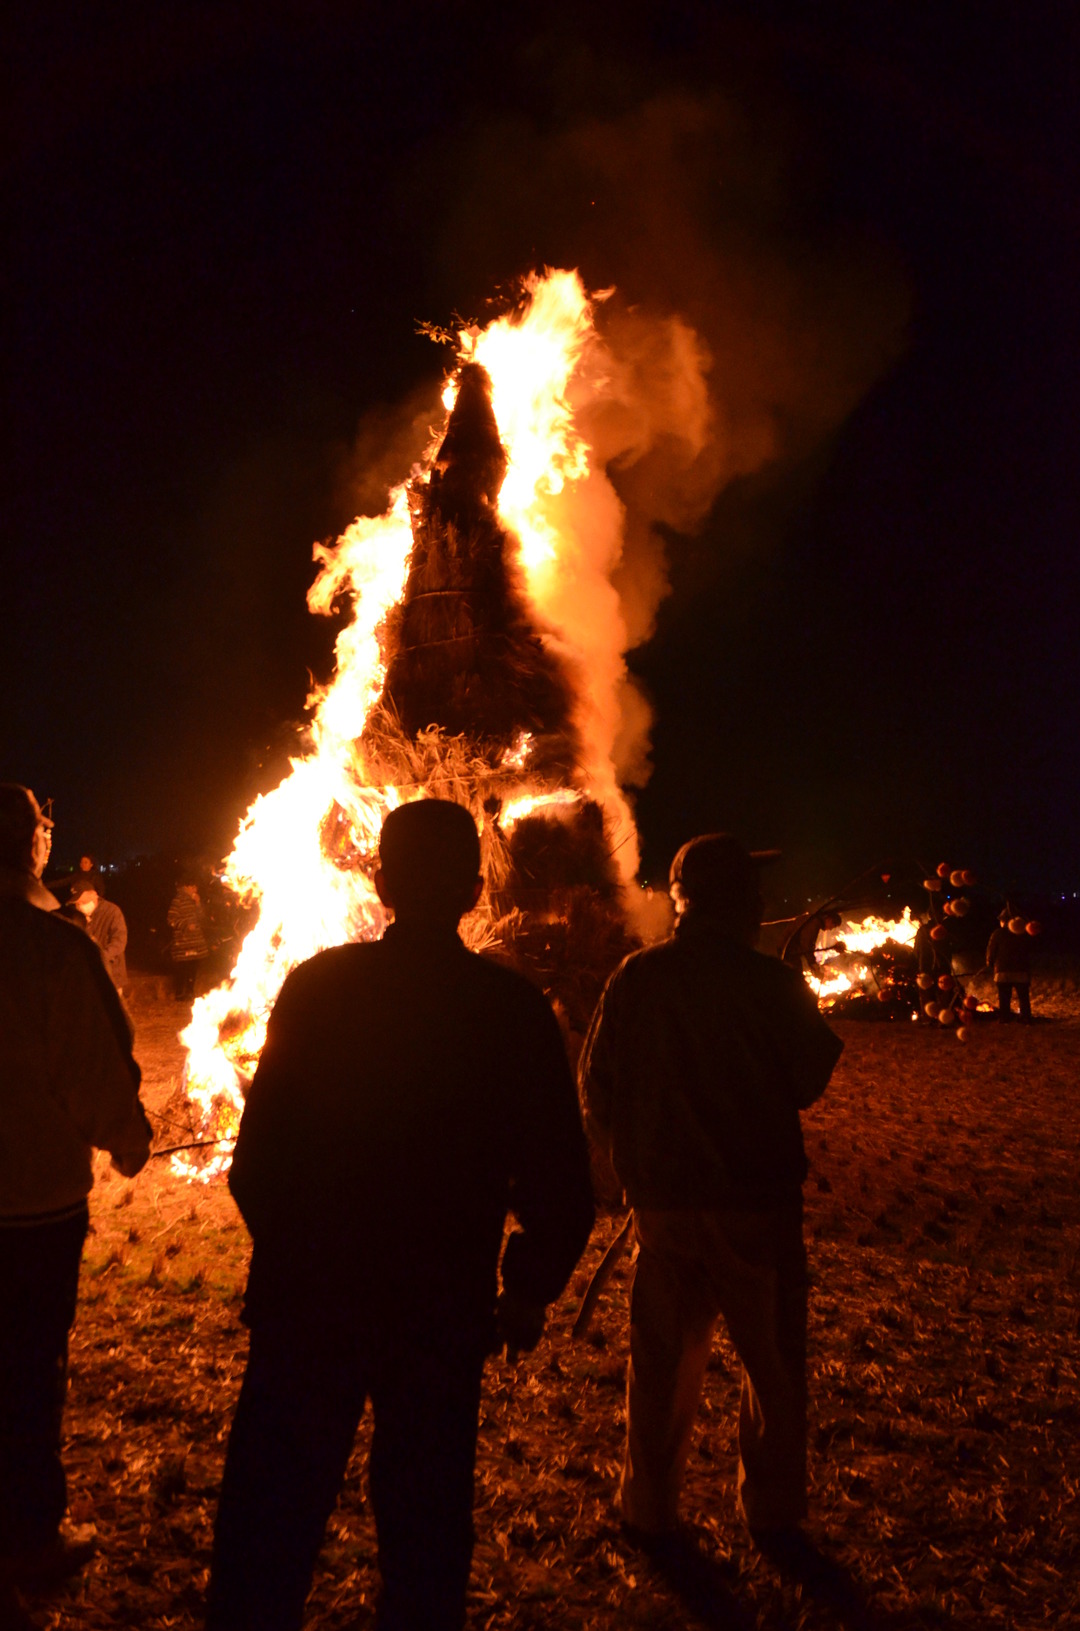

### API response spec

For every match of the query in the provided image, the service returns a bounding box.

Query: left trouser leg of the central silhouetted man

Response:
[207,1329,365,1631]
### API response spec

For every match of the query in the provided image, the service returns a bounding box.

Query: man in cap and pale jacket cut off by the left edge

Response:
[0,783,150,1621]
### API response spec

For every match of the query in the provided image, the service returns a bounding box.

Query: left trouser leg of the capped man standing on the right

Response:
[622,1210,718,1533]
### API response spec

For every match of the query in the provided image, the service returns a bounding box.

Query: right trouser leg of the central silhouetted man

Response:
[370,1349,483,1631]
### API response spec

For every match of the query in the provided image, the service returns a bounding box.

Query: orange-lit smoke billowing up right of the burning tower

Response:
[419,89,909,786]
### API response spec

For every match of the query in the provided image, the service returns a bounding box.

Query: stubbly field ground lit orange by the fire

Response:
[21,982,1080,1631]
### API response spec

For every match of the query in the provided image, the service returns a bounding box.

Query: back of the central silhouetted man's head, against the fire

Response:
[378,799,480,912]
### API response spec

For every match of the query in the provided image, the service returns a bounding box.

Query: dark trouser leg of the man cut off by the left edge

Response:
[0,1207,88,1558]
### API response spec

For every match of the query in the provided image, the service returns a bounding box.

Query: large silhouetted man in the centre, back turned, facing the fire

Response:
[207,799,592,1631]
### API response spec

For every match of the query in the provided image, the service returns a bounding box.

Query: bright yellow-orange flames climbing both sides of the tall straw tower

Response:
[173,271,665,1179]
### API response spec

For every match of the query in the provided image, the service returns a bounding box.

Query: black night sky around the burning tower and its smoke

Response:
[8,0,1080,892]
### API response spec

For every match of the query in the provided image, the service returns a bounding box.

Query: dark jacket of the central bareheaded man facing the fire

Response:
[230,923,592,1341]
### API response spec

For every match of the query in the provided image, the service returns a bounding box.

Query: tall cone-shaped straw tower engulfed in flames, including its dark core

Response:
[175,272,688,1179]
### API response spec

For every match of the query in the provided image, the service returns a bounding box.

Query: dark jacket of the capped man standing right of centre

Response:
[581,910,843,1209]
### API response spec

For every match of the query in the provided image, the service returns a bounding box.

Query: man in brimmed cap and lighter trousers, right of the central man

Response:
[579,833,842,1546]
